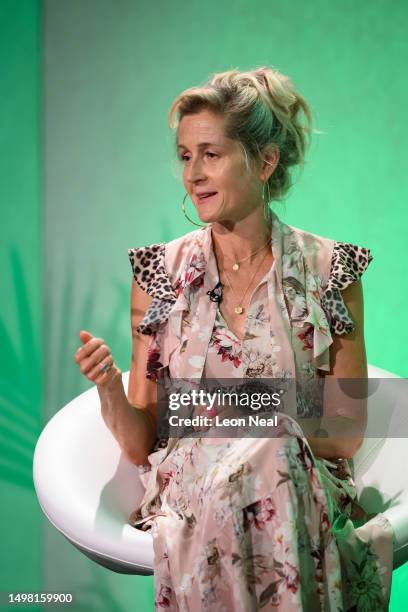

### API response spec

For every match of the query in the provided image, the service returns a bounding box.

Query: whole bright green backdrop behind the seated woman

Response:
[0,0,408,612]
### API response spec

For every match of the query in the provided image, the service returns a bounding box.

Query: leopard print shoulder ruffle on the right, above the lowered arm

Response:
[322,241,373,335]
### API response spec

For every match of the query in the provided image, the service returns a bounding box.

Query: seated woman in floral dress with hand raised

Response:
[76,68,392,612]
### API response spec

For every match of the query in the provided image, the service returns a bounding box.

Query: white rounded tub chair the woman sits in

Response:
[33,366,408,575]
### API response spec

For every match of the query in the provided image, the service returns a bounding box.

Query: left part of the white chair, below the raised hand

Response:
[33,373,153,574]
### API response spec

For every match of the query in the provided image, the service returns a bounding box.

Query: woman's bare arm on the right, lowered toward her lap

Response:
[307,280,367,459]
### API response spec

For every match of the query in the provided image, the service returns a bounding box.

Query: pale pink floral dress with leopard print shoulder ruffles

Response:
[129,215,393,612]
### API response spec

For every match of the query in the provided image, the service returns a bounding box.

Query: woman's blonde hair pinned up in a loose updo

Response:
[169,67,321,202]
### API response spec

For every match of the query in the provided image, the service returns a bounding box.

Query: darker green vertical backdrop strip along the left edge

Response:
[0,0,44,601]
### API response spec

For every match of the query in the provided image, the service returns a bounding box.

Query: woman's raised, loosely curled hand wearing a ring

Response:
[74,331,121,387]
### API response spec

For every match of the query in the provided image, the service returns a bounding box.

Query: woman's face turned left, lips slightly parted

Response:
[177,110,263,223]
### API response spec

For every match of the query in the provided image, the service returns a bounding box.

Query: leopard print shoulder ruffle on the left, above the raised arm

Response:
[128,243,176,335]
